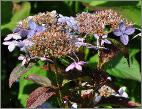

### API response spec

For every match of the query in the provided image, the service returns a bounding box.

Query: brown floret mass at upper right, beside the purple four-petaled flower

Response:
[76,9,133,36]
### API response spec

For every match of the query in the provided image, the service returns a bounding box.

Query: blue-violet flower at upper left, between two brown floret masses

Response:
[27,20,45,38]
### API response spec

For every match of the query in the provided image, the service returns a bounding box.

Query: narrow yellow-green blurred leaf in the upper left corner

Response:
[1,2,31,30]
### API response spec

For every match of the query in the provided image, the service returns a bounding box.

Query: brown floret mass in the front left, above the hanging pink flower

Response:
[29,25,76,57]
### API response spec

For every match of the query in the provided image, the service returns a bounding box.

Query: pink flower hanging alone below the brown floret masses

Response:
[65,61,86,72]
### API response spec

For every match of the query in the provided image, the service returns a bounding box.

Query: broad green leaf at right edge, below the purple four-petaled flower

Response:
[105,55,141,81]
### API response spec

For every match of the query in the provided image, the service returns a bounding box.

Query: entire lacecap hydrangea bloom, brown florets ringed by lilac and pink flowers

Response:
[3,9,135,71]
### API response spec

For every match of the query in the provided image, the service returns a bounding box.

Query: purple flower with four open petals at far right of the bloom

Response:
[113,22,135,45]
